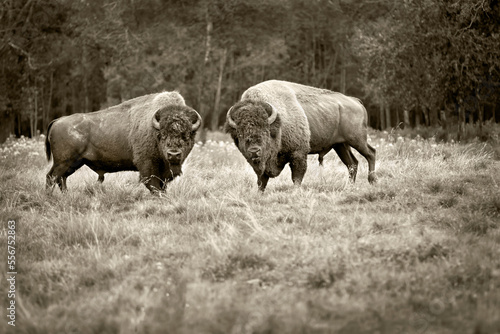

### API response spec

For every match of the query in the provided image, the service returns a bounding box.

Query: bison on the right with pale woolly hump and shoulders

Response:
[225,80,376,191]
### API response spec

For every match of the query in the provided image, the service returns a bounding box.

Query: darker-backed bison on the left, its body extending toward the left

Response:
[45,92,201,192]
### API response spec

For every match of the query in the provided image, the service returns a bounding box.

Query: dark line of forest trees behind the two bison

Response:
[0,0,500,142]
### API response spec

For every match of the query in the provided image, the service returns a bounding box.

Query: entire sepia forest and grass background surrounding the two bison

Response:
[0,0,500,334]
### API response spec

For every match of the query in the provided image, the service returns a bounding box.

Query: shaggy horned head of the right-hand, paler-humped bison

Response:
[226,100,281,175]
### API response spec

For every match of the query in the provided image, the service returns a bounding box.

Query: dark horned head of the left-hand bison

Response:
[152,105,201,176]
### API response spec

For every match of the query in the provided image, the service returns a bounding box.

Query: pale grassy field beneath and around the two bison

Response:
[0,126,500,334]
